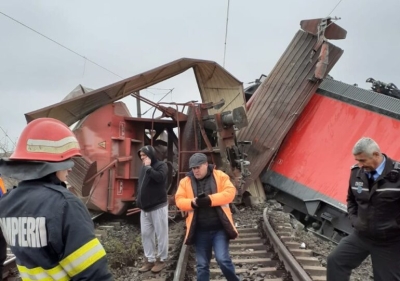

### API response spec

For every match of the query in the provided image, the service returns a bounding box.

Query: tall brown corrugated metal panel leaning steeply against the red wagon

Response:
[238,21,343,186]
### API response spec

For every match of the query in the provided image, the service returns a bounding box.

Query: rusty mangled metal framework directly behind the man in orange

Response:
[178,99,248,189]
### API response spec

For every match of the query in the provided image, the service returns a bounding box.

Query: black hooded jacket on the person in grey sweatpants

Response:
[136,145,168,212]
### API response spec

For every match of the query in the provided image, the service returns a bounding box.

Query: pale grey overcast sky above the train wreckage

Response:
[0,0,400,150]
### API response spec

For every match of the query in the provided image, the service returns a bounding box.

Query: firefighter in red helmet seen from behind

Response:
[0,118,112,281]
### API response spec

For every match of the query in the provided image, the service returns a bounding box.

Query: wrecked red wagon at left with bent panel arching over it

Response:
[26,58,265,215]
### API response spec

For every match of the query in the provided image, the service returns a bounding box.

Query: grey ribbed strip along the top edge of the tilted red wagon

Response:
[318,79,400,119]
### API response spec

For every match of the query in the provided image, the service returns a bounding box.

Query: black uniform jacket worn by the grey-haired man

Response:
[347,156,400,241]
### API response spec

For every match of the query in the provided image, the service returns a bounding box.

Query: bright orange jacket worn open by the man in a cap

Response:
[175,169,238,245]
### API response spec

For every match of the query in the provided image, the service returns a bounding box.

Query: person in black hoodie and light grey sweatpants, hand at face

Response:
[136,145,168,273]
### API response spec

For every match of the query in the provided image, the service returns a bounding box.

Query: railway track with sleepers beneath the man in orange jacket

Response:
[170,208,326,281]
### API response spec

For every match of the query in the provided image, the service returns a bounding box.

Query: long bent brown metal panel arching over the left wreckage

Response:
[25,58,244,125]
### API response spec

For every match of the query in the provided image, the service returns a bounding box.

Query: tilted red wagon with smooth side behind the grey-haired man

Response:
[260,79,400,241]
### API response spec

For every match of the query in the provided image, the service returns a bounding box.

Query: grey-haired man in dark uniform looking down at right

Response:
[327,138,400,281]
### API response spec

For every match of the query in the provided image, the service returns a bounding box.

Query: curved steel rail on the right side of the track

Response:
[263,207,312,281]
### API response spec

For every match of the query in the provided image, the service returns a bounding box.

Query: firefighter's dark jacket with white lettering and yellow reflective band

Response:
[0,176,113,281]
